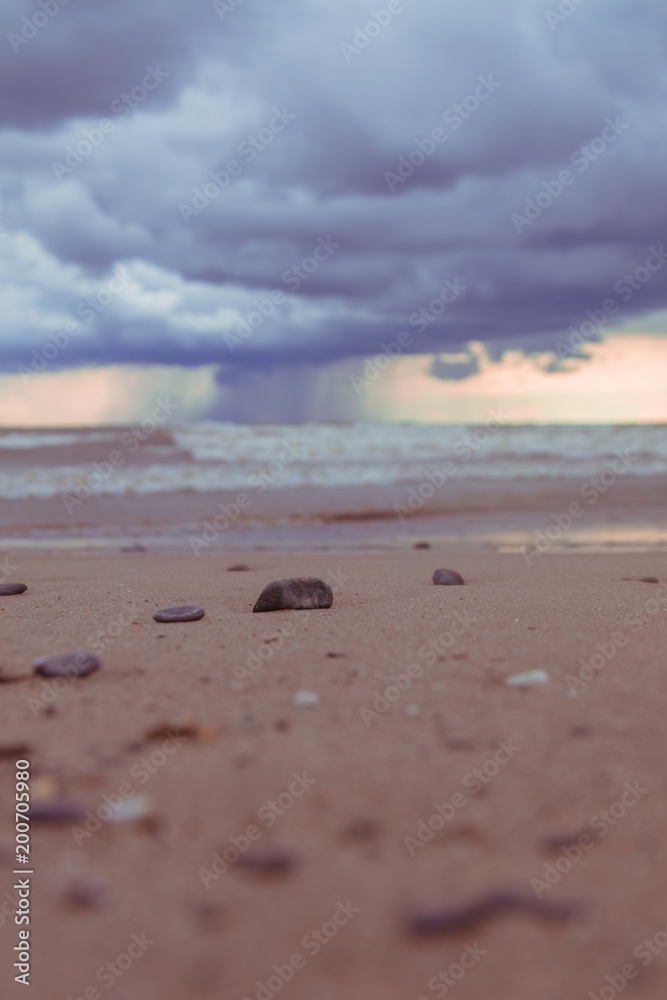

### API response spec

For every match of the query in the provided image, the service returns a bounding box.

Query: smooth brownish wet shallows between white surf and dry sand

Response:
[0,476,667,554]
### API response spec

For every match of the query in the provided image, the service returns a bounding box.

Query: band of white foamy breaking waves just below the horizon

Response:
[0,423,667,498]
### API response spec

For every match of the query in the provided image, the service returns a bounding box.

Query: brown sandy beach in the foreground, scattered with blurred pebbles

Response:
[0,548,667,1000]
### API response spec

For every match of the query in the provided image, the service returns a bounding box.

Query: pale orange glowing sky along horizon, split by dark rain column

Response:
[0,334,667,427]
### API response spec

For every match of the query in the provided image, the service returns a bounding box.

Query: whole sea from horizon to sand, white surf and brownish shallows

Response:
[0,420,667,551]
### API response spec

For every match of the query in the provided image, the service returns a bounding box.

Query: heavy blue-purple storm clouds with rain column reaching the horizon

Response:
[0,0,667,419]
